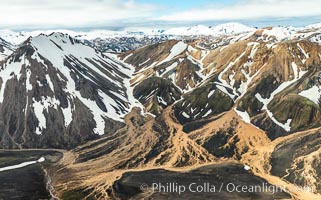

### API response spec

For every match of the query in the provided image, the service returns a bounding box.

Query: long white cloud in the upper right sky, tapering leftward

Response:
[159,0,321,21]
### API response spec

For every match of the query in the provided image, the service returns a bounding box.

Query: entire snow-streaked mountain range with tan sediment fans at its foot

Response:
[0,23,321,199]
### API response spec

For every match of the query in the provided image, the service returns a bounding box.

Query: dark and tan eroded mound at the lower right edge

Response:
[271,130,321,193]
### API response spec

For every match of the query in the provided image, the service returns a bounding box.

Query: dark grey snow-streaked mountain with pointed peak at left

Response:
[0,33,141,148]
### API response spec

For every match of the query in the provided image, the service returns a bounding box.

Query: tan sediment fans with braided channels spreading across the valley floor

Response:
[44,108,321,200]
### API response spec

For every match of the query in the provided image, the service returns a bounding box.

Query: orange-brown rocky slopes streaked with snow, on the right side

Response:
[120,27,321,139]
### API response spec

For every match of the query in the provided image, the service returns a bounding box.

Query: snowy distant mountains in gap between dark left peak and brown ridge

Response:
[83,23,255,53]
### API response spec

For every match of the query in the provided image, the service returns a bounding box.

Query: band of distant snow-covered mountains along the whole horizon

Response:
[0,23,320,53]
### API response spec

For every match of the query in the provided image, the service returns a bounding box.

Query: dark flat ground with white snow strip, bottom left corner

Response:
[0,150,62,200]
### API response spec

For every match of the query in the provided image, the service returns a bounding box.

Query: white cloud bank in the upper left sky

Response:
[0,0,155,28]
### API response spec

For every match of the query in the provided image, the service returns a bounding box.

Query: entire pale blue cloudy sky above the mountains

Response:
[0,0,321,30]
